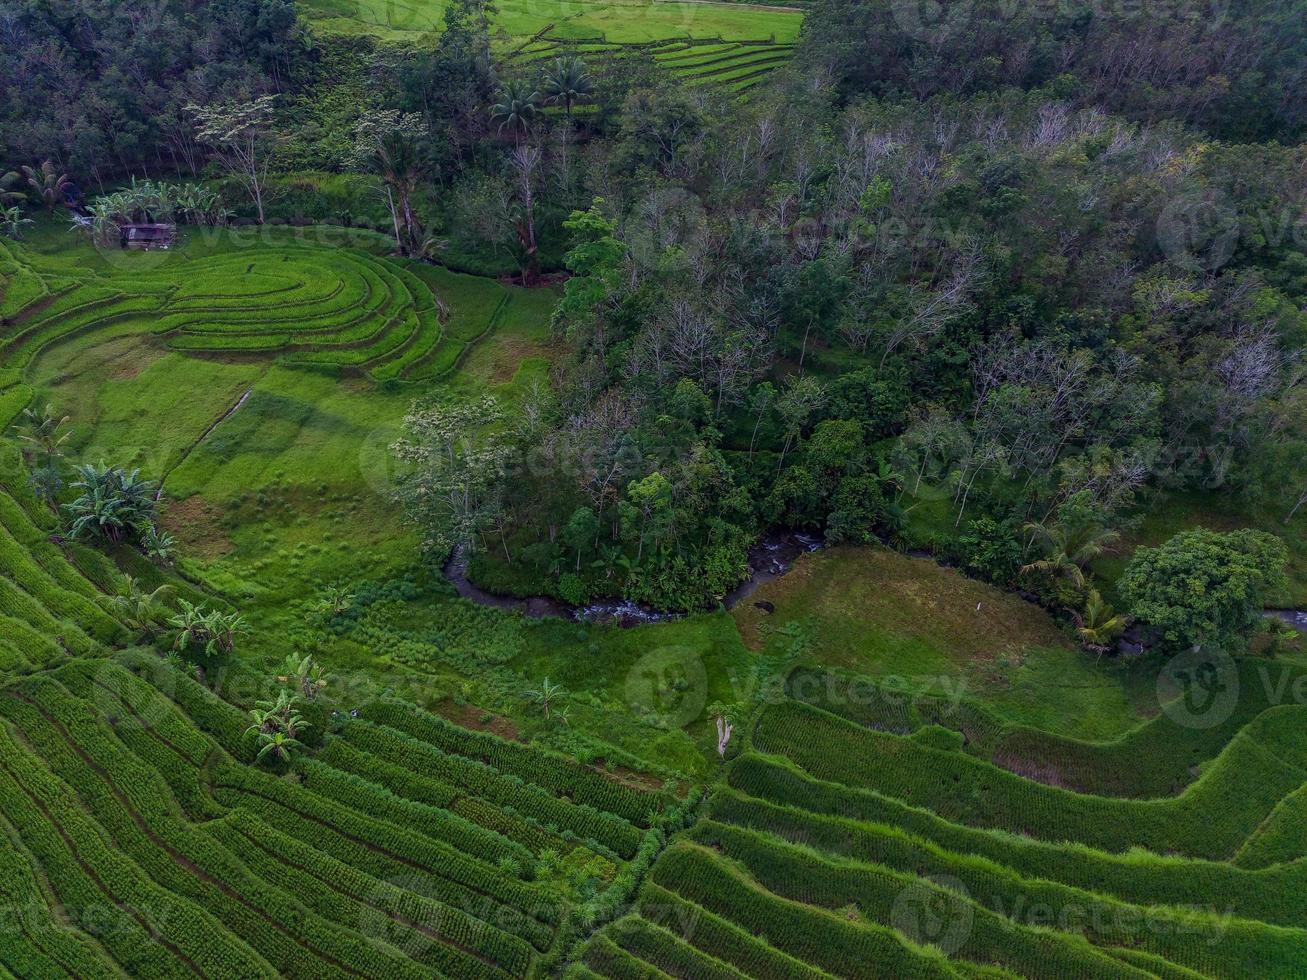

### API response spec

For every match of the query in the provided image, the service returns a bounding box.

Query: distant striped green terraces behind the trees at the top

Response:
[510,33,795,91]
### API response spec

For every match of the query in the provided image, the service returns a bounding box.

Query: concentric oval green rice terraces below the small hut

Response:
[0,233,535,425]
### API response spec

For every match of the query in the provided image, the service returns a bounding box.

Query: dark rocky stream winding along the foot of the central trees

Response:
[442,531,825,626]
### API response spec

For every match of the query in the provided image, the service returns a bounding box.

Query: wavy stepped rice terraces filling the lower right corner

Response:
[578,662,1307,980]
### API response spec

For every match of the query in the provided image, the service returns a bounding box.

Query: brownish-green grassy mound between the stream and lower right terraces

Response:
[735,547,1155,738]
